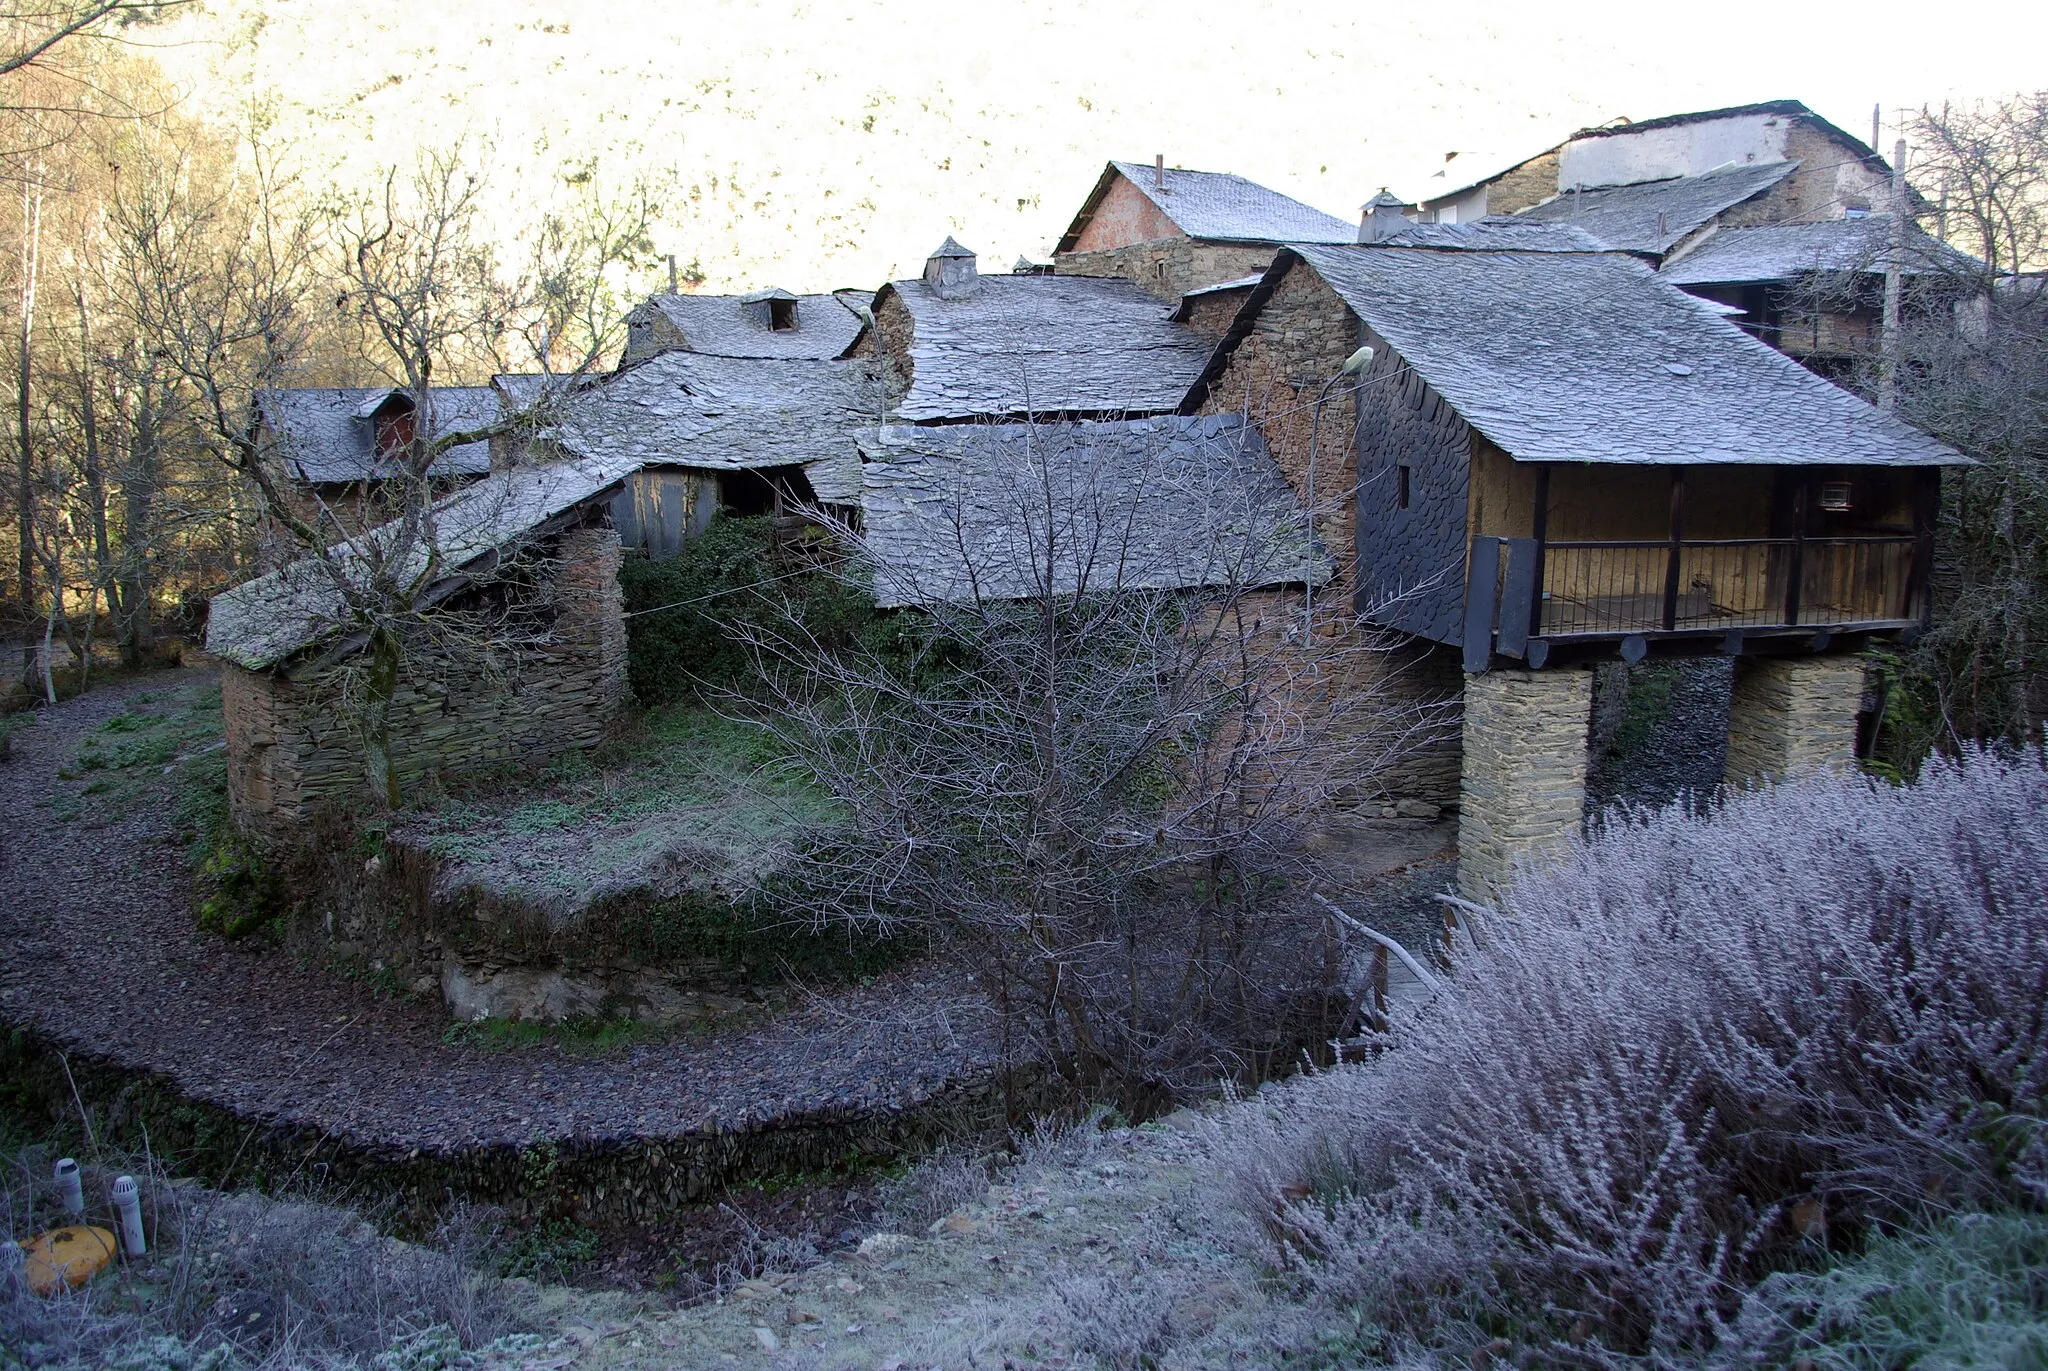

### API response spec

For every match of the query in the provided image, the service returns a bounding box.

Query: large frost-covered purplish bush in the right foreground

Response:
[1225,754,2048,1365]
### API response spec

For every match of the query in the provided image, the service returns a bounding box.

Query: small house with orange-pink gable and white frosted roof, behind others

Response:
[1053,158,1358,303]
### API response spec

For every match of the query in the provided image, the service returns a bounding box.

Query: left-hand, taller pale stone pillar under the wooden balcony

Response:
[1458,666,1593,900]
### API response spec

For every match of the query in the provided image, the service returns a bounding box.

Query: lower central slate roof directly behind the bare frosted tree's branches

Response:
[862,414,1329,607]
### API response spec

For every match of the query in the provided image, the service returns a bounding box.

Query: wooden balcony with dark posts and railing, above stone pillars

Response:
[1464,535,1925,670]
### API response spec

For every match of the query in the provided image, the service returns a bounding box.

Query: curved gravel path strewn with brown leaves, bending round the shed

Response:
[0,668,995,1152]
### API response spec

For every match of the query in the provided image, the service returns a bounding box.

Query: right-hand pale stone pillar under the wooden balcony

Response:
[1722,658,1864,785]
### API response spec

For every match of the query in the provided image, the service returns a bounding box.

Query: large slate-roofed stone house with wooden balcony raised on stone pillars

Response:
[1190,237,1966,894]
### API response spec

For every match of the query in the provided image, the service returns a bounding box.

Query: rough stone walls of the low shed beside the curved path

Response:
[221,529,627,832]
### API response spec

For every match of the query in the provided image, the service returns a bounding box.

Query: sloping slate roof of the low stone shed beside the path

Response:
[207,450,633,670]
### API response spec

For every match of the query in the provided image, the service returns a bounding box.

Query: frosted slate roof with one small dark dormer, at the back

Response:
[621,287,868,365]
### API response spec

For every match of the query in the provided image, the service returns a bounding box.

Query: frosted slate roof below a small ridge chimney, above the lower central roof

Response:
[883,277,1210,424]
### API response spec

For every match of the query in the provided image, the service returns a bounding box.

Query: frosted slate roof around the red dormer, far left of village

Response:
[256,385,498,486]
